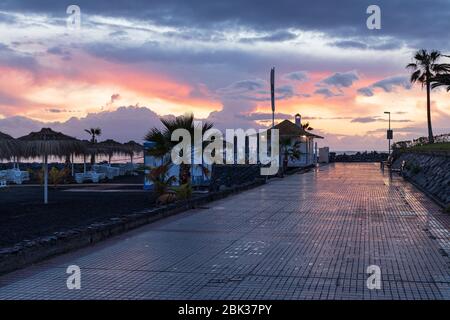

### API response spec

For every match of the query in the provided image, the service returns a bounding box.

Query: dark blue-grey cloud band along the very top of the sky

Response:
[0,0,450,48]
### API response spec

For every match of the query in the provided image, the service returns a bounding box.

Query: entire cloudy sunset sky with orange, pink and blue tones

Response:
[0,0,450,151]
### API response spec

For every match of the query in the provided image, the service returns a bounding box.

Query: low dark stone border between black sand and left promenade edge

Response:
[0,179,266,275]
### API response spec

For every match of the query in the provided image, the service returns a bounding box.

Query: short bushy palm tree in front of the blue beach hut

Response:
[145,113,213,184]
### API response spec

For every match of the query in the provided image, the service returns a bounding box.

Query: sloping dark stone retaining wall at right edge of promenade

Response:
[392,152,450,207]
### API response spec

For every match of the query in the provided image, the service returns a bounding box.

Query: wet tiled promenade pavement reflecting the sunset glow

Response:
[0,164,450,299]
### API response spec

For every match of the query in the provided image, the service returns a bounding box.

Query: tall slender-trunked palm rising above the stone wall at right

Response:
[406,49,450,143]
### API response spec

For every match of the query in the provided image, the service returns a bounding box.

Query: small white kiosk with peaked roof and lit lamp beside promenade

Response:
[274,113,323,167]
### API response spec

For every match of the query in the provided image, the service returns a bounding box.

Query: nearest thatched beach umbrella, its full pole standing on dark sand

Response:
[19,128,84,203]
